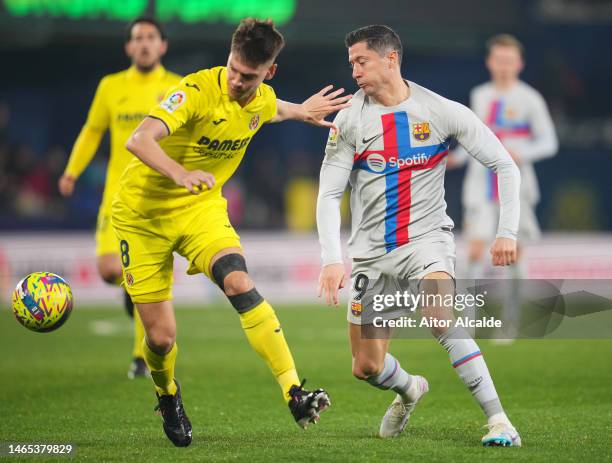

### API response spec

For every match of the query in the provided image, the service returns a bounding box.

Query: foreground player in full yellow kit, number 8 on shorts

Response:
[112,18,351,447]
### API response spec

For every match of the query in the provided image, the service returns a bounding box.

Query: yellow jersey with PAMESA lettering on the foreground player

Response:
[117,66,276,216]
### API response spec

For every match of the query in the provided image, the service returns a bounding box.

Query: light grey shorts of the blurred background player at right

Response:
[463,201,541,241]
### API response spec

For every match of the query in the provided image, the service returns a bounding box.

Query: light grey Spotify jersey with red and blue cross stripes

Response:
[317,82,520,265]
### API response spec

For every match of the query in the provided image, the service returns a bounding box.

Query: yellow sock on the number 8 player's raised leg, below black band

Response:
[240,301,300,402]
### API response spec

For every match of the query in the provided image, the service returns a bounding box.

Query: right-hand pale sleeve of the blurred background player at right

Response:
[518,93,559,162]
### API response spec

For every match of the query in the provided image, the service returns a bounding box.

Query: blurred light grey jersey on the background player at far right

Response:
[458,81,558,207]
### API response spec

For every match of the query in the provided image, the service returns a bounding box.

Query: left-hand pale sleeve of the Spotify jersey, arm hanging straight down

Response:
[317,110,355,265]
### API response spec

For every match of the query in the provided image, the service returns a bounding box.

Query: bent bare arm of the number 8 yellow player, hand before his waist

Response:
[125,117,215,194]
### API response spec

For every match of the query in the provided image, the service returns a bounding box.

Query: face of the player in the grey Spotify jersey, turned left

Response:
[348,42,393,95]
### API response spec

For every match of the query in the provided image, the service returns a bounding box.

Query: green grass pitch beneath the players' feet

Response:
[0,306,612,462]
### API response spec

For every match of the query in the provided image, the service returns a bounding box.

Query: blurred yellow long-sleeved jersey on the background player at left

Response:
[66,66,181,210]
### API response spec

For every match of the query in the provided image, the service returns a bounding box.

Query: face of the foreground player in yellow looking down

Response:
[227,53,276,102]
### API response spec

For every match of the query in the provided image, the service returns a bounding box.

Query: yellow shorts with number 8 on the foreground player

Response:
[112,198,242,303]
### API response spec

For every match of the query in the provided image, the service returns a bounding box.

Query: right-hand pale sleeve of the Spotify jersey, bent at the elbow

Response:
[449,101,521,239]
